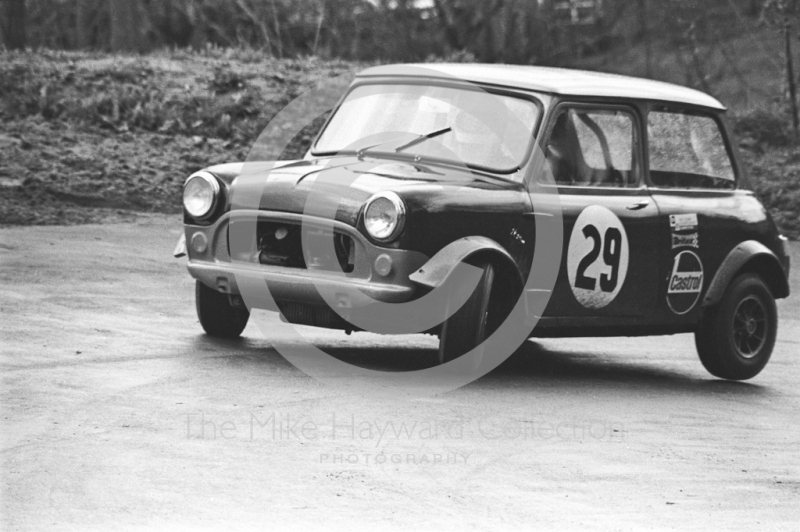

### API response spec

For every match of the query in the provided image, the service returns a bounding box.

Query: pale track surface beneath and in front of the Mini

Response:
[0,216,800,531]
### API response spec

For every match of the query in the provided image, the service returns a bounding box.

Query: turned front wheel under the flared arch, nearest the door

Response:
[439,263,495,364]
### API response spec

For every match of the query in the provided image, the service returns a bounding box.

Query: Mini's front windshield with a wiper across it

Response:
[314,84,539,172]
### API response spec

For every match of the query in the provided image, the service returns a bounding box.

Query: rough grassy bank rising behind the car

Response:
[0,49,800,238]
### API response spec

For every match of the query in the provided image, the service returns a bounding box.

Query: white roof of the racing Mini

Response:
[358,63,725,110]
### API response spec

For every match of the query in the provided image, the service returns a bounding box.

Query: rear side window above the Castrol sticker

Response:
[647,111,736,189]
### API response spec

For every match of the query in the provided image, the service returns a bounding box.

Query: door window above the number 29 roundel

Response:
[545,108,641,187]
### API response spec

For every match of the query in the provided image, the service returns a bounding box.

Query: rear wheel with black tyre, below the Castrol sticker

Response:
[695,274,778,380]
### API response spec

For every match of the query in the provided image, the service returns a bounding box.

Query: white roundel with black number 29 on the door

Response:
[567,205,628,309]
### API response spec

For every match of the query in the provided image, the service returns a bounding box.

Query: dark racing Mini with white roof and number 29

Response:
[176,64,789,380]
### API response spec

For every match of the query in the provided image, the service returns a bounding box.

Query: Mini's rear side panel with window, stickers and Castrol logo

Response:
[647,105,752,320]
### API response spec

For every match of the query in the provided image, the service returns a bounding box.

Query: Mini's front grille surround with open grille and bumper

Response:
[185,210,428,314]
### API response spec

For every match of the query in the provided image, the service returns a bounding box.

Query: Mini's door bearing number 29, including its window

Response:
[532,103,658,325]
